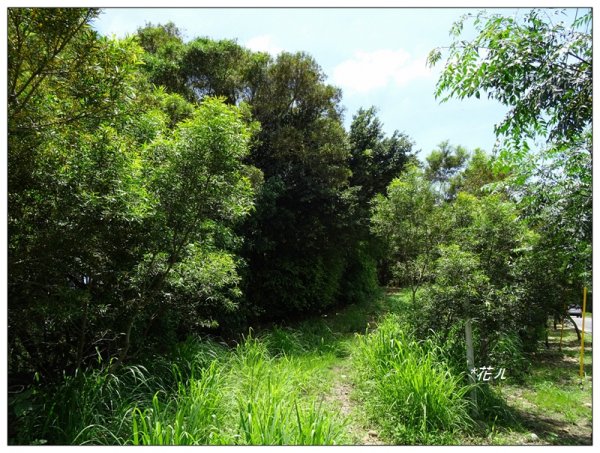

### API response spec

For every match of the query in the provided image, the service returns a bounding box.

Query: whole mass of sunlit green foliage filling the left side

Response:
[8,9,254,379]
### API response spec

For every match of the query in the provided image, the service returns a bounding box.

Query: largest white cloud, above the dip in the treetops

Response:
[333,49,432,93]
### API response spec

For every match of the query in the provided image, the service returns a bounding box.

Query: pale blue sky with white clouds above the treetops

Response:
[94,8,580,158]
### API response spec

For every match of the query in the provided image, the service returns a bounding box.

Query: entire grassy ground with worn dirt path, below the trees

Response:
[9,291,592,445]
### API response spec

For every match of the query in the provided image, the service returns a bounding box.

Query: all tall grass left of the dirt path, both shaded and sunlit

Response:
[12,329,349,445]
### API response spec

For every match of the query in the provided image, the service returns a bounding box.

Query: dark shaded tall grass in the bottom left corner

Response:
[10,364,162,445]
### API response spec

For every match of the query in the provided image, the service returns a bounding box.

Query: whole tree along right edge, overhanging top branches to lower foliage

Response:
[429,9,592,324]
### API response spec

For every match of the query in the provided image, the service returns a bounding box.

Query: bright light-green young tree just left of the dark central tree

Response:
[121,98,252,358]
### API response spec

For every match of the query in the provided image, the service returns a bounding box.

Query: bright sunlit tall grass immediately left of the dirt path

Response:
[131,332,345,445]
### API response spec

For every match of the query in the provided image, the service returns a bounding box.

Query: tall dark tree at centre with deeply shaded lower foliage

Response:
[245,53,354,316]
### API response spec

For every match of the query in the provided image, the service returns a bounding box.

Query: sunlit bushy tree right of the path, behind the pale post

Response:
[372,158,540,369]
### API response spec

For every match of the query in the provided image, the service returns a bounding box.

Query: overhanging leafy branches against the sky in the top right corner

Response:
[429,9,592,151]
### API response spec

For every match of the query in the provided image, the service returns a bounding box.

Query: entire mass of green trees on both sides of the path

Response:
[8,8,592,392]
